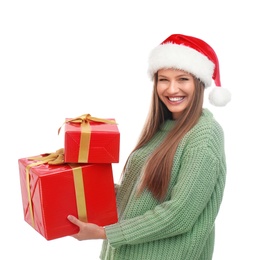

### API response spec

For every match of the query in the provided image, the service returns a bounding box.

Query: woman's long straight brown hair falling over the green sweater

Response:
[123,73,204,201]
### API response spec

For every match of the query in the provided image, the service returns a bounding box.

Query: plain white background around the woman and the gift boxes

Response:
[0,0,265,260]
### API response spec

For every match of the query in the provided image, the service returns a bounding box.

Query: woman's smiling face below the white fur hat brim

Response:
[156,69,195,119]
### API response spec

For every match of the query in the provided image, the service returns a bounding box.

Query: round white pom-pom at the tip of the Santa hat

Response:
[209,87,231,107]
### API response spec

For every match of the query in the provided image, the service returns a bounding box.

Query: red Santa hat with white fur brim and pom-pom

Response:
[148,34,231,106]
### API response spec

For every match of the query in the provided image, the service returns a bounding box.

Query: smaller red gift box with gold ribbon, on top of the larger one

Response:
[61,114,120,163]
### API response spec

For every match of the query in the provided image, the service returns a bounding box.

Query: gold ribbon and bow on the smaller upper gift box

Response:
[58,114,117,163]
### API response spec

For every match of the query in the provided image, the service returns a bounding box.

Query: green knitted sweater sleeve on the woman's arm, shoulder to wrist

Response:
[106,147,222,247]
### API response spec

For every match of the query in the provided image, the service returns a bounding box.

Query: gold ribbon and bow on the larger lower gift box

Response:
[26,148,87,227]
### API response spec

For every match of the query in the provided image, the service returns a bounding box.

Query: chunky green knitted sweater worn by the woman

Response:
[100,109,226,260]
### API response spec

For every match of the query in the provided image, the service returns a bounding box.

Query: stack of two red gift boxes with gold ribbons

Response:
[18,114,120,240]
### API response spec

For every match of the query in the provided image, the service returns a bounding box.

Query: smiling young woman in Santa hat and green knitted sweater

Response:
[68,34,230,260]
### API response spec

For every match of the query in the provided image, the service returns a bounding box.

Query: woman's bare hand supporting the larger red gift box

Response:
[67,215,106,241]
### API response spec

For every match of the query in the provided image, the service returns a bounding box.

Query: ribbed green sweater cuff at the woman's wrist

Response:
[105,223,125,248]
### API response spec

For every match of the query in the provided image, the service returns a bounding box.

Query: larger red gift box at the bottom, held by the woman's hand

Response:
[18,155,117,240]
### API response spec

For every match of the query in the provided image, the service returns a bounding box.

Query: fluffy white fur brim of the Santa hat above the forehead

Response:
[148,43,215,87]
